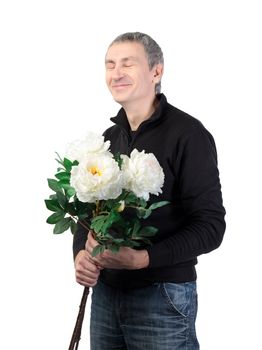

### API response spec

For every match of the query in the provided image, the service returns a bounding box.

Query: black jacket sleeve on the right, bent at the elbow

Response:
[147,128,225,268]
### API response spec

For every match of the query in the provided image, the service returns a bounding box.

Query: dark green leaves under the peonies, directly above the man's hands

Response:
[90,190,168,256]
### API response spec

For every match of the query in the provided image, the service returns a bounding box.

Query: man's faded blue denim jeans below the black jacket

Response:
[90,282,199,350]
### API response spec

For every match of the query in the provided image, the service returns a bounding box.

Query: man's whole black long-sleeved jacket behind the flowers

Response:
[74,94,225,288]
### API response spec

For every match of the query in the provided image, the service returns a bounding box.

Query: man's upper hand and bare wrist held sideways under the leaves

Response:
[86,231,149,270]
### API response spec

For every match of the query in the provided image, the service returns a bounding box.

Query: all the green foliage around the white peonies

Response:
[45,154,169,256]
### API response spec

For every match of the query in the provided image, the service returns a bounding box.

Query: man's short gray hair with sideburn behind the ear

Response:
[109,32,164,94]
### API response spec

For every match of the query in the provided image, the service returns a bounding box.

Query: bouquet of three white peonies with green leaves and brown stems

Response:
[45,132,168,350]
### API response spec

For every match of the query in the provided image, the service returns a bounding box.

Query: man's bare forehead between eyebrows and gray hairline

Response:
[105,41,147,61]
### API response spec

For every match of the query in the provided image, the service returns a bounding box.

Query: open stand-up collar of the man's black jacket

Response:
[110,94,167,131]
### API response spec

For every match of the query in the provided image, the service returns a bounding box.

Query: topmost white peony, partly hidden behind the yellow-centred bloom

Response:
[65,132,110,161]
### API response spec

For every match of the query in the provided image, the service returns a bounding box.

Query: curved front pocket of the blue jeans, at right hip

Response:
[161,282,192,317]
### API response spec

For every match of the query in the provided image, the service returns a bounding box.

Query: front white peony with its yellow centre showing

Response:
[70,152,123,203]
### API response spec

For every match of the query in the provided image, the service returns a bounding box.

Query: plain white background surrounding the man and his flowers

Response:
[0,0,262,350]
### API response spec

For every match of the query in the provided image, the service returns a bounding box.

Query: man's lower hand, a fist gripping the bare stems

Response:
[75,250,100,287]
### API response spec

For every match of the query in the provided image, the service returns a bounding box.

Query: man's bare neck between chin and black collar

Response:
[122,95,157,131]
